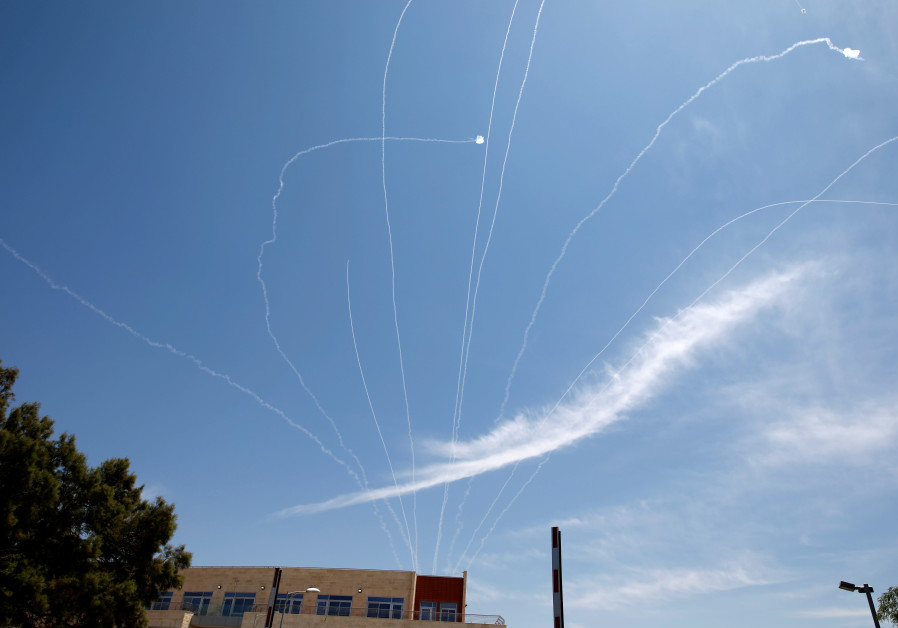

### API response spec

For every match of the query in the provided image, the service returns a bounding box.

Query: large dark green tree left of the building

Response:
[0,366,190,628]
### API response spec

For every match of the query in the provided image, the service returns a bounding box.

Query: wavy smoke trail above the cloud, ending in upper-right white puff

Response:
[499,37,859,416]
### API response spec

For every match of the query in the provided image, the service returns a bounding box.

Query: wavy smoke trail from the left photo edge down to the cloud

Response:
[0,238,364,488]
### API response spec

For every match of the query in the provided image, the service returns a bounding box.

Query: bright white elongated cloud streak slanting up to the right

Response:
[276,265,812,517]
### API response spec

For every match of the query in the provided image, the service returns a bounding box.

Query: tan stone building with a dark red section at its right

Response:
[147,567,505,628]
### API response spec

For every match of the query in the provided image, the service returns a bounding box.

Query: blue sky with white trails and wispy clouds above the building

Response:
[0,0,898,628]
